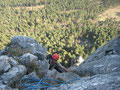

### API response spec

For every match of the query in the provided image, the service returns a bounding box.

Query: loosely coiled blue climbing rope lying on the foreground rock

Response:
[20,77,80,90]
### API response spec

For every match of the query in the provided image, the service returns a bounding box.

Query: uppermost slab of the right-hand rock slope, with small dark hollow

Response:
[84,36,120,63]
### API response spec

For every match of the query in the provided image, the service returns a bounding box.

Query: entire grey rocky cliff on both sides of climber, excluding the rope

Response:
[0,36,120,90]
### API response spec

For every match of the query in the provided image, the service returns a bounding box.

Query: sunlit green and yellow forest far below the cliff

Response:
[0,0,120,66]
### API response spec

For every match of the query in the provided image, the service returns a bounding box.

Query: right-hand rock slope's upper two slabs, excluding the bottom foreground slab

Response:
[74,36,120,76]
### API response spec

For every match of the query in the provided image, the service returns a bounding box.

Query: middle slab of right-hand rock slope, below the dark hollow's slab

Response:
[73,55,120,76]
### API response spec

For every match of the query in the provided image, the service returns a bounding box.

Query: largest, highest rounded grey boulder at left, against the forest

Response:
[6,36,47,60]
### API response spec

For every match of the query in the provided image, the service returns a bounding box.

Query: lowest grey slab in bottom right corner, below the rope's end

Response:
[47,72,120,90]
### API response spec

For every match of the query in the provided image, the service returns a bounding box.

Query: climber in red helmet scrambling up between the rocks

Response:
[47,54,68,73]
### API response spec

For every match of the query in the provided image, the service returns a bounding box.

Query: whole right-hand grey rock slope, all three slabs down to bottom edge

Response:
[48,36,120,90]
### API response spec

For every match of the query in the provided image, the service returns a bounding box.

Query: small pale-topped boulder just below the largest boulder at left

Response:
[20,53,38,67]
